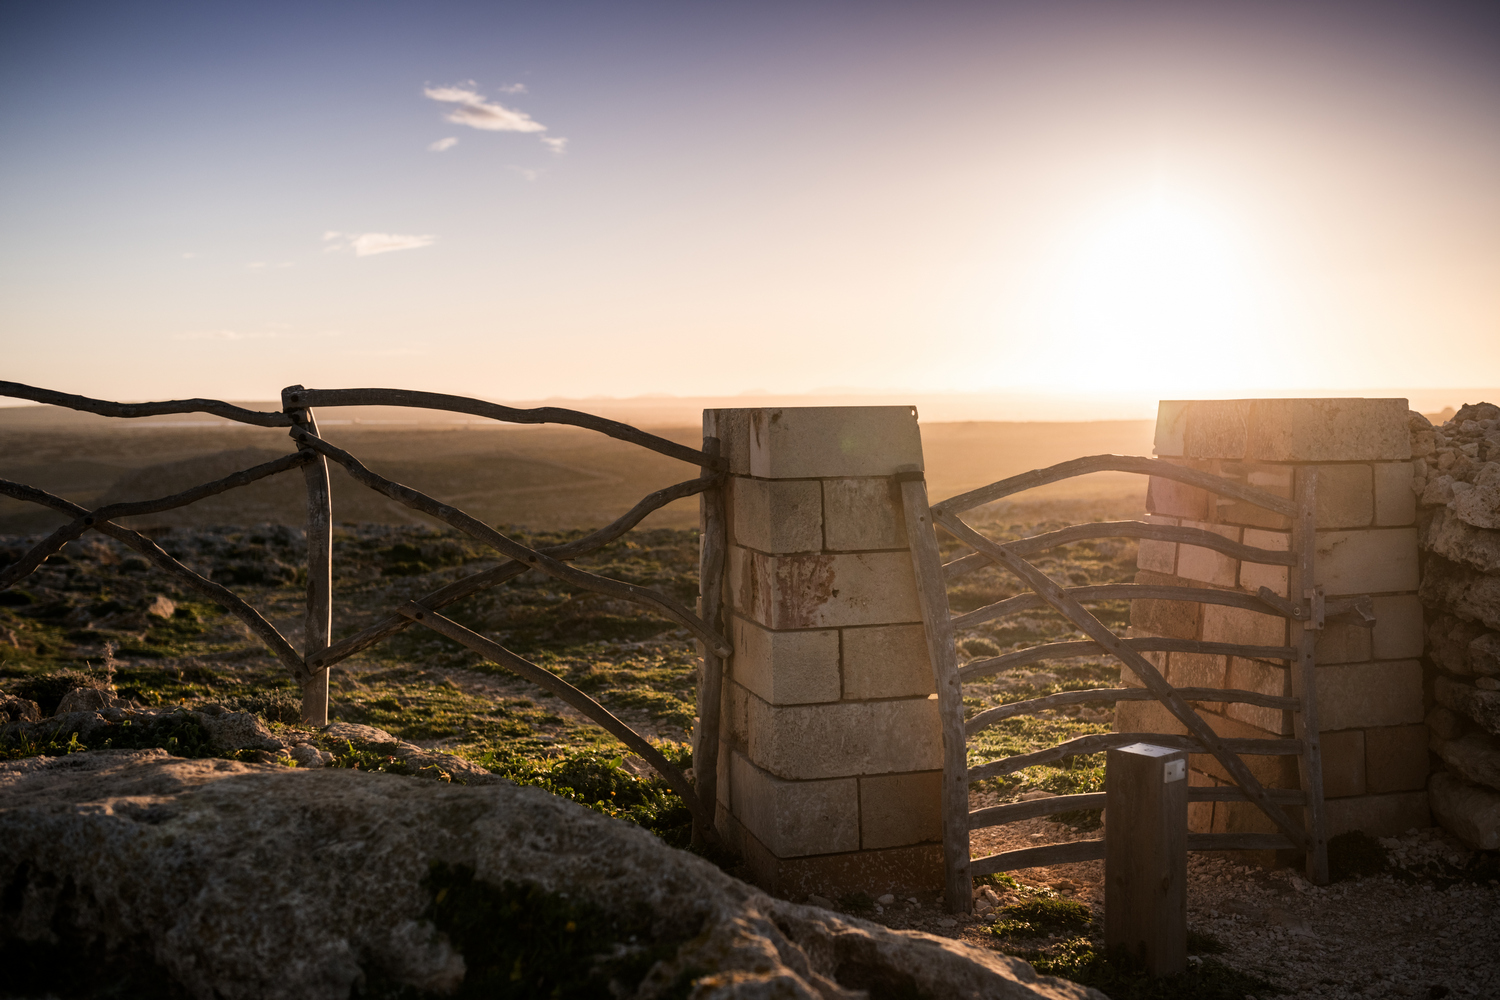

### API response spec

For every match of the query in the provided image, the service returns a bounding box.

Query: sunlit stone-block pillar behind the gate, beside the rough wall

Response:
[1116,399,1430,837]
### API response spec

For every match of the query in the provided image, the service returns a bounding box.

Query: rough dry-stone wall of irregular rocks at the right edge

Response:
[1410,403,1500,850]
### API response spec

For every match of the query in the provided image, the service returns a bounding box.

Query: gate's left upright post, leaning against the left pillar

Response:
[902,472,974,913]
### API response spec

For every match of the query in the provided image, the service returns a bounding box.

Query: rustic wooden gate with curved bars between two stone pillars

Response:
[902,454,1374,912]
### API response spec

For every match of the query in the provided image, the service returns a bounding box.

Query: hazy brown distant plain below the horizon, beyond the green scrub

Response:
[0,406,1152,534]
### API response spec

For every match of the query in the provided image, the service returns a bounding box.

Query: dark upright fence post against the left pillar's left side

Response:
[693,438,729,843]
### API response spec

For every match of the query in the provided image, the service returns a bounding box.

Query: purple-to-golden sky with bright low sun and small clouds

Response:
[0,0,1500,410]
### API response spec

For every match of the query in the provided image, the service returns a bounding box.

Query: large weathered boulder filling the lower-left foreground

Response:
[0,750,1103,1000]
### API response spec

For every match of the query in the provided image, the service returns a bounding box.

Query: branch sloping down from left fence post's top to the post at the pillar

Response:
[291,427,731,657]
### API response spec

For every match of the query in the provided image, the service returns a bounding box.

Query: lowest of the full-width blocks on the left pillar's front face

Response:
[746,694,942,780]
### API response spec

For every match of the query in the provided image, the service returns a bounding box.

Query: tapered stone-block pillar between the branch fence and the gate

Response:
[704,406,942,900]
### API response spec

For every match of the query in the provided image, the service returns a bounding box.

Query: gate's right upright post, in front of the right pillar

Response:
[1290,466,1329,886]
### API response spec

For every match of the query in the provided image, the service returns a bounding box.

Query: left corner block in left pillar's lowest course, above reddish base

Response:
[731,753,860,858]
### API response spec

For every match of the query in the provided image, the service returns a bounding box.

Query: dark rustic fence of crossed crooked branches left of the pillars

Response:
[0,381,729,840]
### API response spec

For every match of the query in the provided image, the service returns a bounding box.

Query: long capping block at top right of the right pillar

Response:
[1236,399,1412,462]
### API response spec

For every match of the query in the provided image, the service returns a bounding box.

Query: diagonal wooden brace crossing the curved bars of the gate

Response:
[935,514,1313,849]
